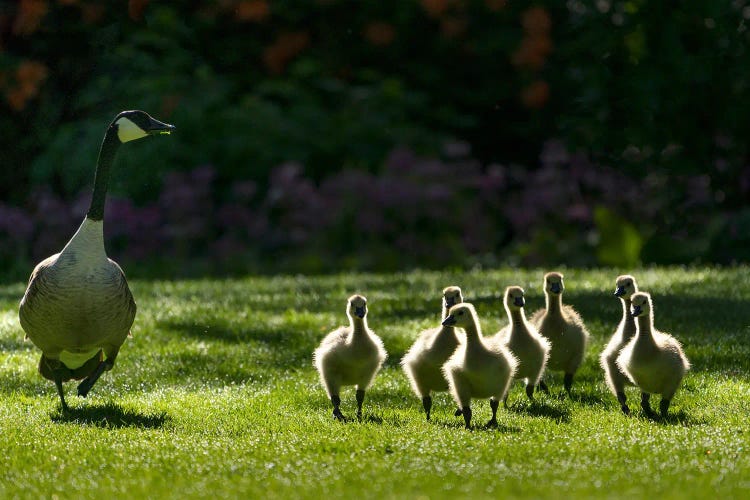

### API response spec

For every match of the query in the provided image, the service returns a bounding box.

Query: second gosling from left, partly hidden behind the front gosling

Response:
[401,286,464,421]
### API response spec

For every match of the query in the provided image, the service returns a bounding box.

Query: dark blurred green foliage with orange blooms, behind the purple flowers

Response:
[0,0,750,270]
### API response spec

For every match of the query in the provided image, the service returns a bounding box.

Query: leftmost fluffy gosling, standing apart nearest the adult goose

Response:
[313,295,388,421]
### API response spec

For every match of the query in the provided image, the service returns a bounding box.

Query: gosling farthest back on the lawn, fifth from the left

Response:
[530,272,589,397]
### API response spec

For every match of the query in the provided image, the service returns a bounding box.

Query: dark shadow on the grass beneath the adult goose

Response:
[50,402,171,429]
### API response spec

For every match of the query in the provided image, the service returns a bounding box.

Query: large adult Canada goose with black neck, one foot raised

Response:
[18,111,175,411]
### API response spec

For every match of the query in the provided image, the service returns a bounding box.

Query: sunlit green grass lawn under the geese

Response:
[0,267,750,498]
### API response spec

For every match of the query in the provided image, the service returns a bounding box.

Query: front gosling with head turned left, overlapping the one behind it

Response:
[443,303,518,429]
